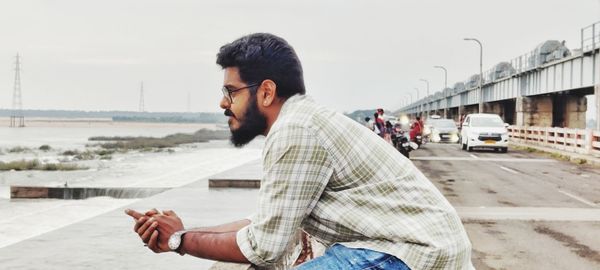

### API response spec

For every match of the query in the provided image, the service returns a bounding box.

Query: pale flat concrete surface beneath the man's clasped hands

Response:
[0,159,258,269]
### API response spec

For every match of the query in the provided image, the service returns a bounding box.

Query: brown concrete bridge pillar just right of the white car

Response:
[515,96,552,127]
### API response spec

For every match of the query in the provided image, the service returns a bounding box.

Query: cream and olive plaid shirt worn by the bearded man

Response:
[237,95,473,269]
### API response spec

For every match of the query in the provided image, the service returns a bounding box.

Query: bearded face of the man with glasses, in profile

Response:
[220,67,267,147]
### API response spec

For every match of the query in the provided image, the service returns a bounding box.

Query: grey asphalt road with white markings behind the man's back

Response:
[411,143,600,269]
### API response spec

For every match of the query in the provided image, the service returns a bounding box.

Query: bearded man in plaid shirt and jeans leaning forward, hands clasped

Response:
[126,34,472,269]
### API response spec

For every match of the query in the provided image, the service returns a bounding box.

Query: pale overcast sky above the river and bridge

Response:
[0,0,600,112]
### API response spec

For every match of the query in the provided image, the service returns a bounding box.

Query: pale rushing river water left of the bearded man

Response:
[0,119,263,248]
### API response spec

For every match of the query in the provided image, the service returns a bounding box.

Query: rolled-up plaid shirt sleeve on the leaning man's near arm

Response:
[236,127,333,266]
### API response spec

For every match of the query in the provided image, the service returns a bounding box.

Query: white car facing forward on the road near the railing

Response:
[460,113,508,153]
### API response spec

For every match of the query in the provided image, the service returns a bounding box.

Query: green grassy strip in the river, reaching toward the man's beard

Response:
[89,129,229,152]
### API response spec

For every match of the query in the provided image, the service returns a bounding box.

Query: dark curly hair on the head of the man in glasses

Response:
[217,33,306,99]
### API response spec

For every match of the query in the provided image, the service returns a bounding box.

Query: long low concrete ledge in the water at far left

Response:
[10,186,168,200]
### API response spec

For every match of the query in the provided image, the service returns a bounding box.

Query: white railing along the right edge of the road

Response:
[508,126,600,156]
